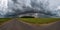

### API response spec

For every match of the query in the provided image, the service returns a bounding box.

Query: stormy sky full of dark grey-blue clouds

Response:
[0,0,60,18]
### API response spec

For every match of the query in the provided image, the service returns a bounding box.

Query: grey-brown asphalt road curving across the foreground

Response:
[0,19,60,30]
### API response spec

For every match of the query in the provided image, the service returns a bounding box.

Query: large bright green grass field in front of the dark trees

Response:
[18,18,60,24]
